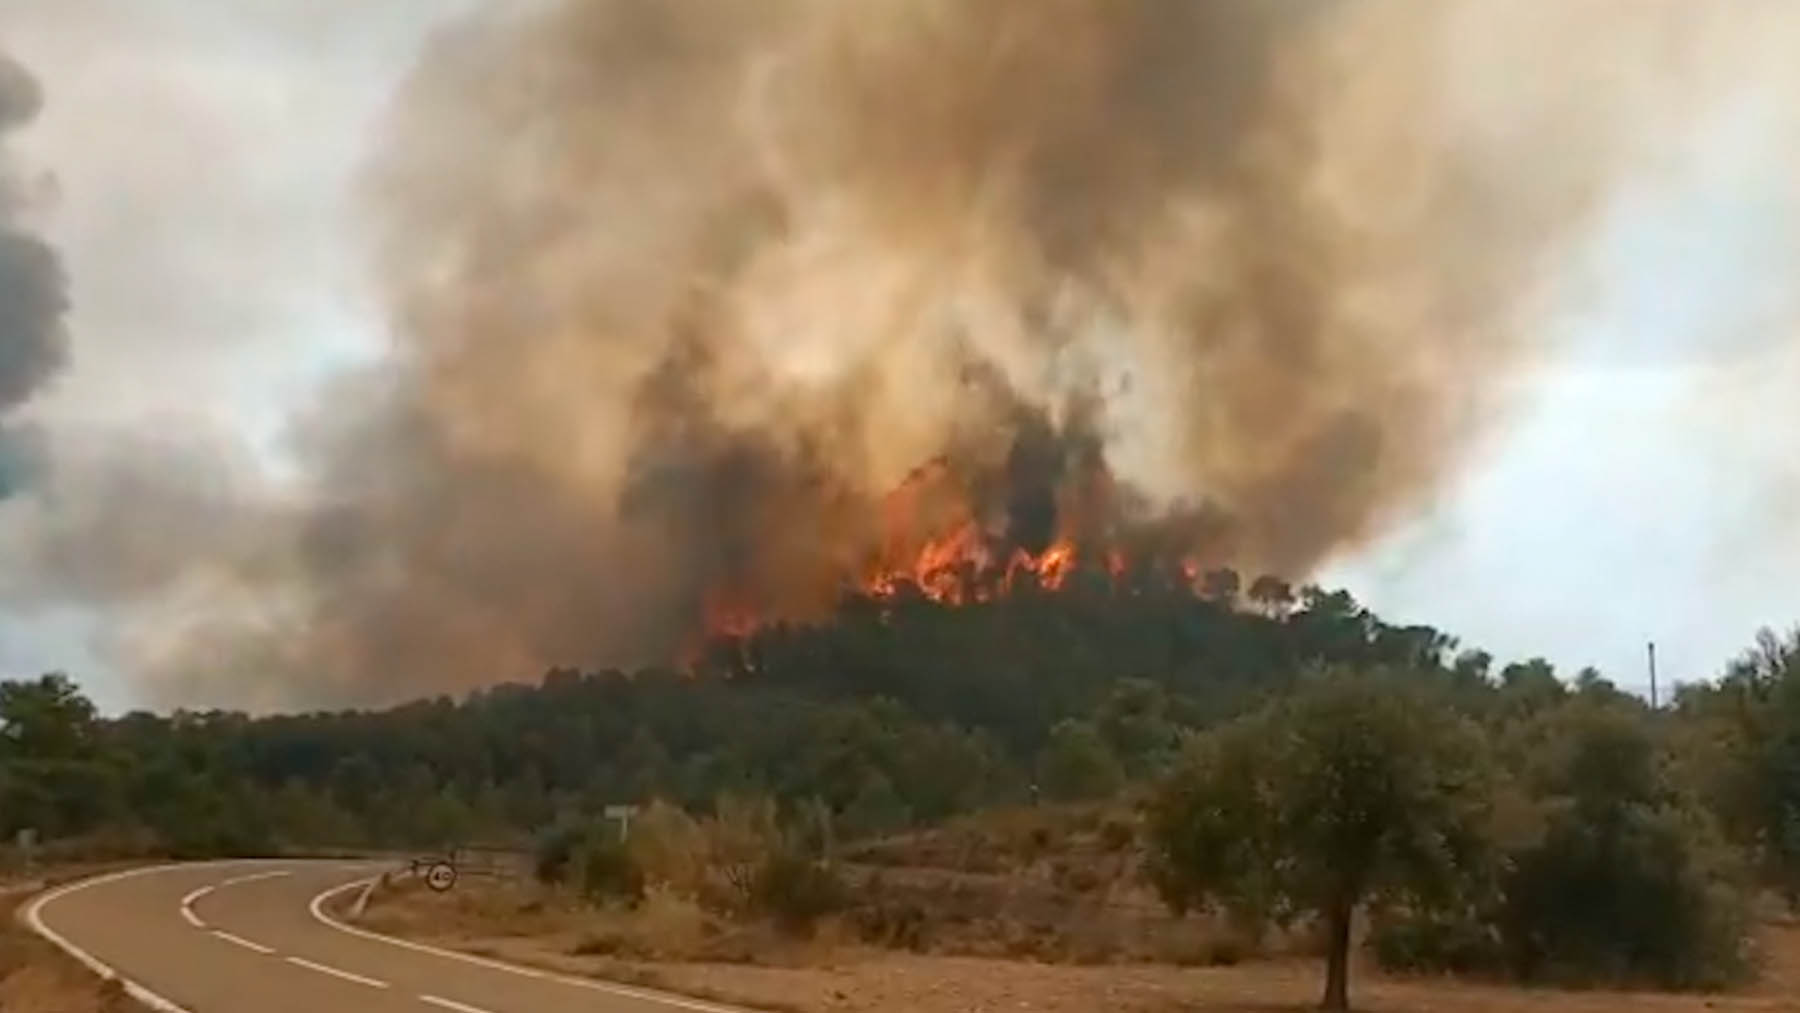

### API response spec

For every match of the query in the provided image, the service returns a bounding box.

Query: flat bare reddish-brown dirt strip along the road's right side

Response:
[367,887,1800,1013]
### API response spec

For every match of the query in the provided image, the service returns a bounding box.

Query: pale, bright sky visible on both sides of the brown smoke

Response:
[0,0,1800,711]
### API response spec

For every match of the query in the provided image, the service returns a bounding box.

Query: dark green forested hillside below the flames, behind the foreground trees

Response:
[0,574,1490,853]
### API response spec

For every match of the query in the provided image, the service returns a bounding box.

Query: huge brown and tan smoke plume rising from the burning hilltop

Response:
[0,0,1771,704]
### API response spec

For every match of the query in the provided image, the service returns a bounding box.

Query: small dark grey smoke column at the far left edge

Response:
[0,50,68,498]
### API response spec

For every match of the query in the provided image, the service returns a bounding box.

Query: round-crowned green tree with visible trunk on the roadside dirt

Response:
[1150,673,1490,1009]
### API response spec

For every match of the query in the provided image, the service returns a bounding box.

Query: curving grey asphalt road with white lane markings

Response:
[20,862,734,1013]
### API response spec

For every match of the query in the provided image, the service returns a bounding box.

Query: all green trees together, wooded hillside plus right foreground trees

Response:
[0,570,1800,1004]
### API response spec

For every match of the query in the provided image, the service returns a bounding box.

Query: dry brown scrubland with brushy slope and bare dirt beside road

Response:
[364,810,1800,1013]
